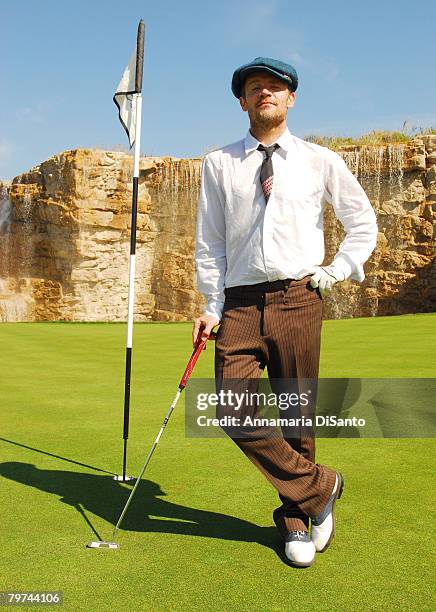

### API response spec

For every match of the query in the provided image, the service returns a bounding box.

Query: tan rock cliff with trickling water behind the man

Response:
[0,135,436,321]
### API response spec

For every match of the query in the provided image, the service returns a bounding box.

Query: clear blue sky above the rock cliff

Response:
[0,0,436,179]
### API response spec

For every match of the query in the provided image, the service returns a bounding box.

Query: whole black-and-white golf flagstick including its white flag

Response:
[113,19,144,482]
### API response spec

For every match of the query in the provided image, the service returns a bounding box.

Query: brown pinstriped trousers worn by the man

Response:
[215,276,336,531]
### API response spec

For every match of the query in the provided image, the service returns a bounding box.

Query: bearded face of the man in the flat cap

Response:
[239,72,296,129]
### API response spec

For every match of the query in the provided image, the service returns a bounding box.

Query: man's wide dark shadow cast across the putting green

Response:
[0,461,279,552]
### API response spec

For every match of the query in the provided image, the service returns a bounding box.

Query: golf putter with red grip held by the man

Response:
[87,330,215,548]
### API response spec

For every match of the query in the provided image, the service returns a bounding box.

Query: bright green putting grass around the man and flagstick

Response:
[0,315,436,611]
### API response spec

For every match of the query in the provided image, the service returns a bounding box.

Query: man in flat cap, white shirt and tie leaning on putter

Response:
[193,57,377,567]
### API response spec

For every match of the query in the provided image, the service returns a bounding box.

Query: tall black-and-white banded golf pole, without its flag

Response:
[114,19,144,482]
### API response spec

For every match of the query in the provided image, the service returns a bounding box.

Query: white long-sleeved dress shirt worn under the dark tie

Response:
[195,128,377,319]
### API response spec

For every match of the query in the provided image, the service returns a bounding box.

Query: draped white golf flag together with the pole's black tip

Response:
[113,19,144,148]
